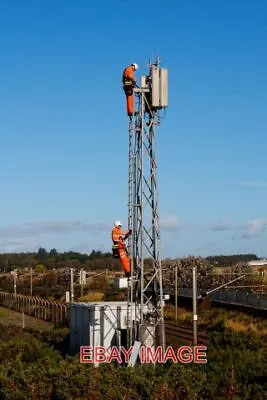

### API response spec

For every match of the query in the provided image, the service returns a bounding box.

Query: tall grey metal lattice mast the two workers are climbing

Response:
[128,58,168,347]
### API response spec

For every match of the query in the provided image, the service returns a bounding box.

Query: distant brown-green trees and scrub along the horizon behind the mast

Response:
[0,248,263,300]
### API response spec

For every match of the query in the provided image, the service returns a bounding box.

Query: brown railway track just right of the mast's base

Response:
[165,322,210,345]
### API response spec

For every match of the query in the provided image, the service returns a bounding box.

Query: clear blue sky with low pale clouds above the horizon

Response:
[0,0,267,257]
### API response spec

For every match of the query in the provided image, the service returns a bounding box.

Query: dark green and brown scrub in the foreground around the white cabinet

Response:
[0,310,267,400]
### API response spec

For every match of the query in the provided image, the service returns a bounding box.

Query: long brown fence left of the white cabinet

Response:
[0,291,69,323]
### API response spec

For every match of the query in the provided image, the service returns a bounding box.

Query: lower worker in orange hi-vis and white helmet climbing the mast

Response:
[111,221,132,278]
